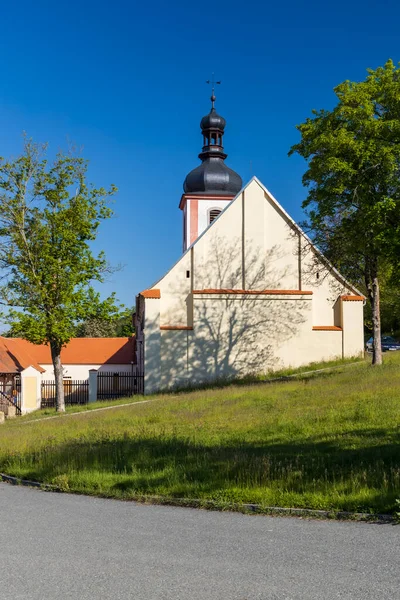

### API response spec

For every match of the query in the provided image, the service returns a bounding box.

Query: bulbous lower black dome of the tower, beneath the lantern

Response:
[183,157,242,196]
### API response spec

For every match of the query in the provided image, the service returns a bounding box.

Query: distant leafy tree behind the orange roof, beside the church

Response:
[76,307,135,337]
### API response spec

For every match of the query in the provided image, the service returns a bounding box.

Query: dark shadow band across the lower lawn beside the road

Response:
[17,428,400,513]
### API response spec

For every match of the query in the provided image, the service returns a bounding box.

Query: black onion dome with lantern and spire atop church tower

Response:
[183,93,242,196]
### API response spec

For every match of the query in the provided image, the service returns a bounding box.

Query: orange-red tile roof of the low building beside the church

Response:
[1,337,136,368]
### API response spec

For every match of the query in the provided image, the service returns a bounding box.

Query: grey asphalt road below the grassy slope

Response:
[0,483,400,600]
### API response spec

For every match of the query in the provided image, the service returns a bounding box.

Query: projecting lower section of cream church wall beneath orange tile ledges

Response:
[160,295,342,388]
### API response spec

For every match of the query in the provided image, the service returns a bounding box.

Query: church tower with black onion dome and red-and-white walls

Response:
[179,89,242,252]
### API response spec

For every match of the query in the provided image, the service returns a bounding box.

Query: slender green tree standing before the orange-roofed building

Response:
[0,140,116,411]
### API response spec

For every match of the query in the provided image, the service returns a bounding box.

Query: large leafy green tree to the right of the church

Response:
[289,60,400,364]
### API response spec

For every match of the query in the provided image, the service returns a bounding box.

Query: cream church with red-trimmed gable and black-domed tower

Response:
[136,91,365,394]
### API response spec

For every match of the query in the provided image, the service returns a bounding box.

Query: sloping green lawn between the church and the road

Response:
[0,353,400,513]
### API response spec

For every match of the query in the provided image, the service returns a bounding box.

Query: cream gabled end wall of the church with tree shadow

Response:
[145,180,363,393]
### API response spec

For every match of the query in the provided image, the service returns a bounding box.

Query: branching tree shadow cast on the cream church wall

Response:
[155,237,310,388]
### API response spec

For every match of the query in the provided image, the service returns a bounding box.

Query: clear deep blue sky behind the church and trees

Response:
[0,0,400,304]
